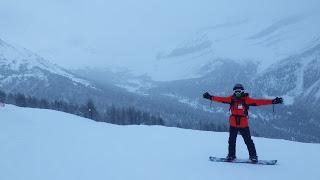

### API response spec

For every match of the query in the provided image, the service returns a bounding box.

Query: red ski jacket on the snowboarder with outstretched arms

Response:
[211,94,272,128]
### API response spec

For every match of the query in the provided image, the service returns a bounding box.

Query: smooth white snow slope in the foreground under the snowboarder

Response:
[0,105,320,180]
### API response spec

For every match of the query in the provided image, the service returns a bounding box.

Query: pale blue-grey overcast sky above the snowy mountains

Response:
[0,0,320,72]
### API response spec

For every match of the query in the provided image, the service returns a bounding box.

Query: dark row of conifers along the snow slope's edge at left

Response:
[0,90,164,125]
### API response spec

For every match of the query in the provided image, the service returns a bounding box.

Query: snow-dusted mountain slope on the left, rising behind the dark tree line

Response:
[0,40,150,108]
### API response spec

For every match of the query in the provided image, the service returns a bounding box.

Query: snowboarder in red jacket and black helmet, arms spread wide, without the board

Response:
[203,84,283,162]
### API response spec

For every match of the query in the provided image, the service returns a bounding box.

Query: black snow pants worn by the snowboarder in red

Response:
[228,126,257,156]
